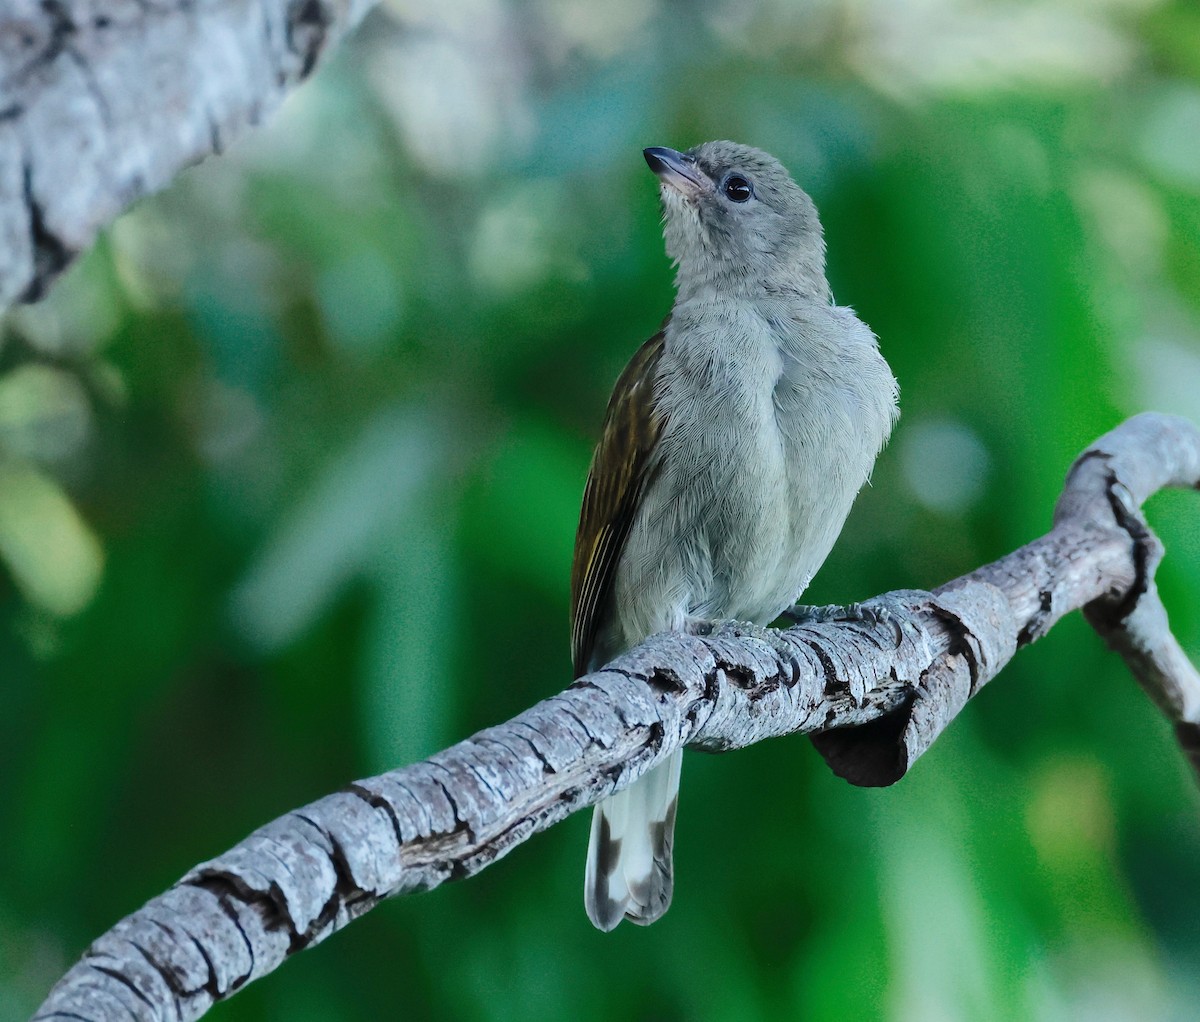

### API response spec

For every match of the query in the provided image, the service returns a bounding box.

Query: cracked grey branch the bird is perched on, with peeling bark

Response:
[36,414,1200,1020]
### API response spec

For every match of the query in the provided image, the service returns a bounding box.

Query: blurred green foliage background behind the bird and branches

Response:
[0,0,1200,1022]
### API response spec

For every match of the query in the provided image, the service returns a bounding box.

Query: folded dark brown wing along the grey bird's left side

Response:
[571,324,666,678]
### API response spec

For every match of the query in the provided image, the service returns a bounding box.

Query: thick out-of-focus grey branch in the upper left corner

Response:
[0,0,374,308]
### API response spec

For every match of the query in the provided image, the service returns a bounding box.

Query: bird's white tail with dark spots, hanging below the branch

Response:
[583,749,683,932]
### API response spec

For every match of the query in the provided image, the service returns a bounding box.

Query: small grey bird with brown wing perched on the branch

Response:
[571,142,898,931]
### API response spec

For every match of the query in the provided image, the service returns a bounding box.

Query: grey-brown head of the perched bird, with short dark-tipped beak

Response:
[644,142,828,297]
